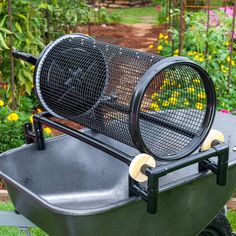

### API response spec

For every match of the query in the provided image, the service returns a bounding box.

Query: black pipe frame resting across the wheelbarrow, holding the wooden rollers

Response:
[24,112,229,214]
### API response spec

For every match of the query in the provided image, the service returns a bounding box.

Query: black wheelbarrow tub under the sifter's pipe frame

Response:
[0,114,236,236]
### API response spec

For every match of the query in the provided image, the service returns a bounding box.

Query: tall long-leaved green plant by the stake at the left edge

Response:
[0,0,45,103]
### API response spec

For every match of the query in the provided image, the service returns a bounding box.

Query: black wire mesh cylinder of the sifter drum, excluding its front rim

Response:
[35,35,216,159]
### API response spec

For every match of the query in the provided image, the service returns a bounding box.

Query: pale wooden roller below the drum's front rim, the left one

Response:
[129,153,156,182]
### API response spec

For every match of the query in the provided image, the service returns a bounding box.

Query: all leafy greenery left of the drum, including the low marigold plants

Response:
[0,0,89,152]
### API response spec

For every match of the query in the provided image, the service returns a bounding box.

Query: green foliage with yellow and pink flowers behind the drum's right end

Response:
[157,10,236,110]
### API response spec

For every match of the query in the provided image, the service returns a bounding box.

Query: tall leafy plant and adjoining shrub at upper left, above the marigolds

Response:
[0,0,88,107]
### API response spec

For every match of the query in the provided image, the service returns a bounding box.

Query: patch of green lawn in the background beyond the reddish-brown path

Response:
[111,7,158,24]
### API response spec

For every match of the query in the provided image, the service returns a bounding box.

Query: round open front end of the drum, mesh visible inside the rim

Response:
[139,65,207,158]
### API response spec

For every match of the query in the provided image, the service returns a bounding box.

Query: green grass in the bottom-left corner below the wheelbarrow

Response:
[0,202,48,236]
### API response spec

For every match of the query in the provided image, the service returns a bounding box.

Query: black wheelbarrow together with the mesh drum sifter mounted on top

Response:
[0,35,236,236]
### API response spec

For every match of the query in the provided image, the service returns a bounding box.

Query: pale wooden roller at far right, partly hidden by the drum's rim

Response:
[200,129,225,151]
